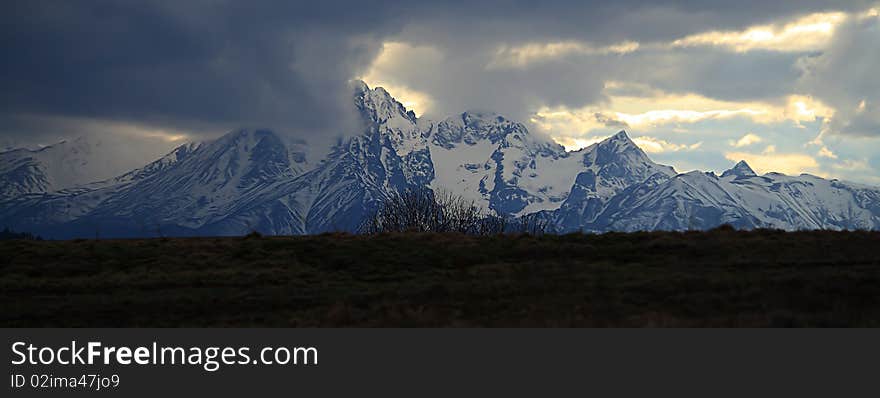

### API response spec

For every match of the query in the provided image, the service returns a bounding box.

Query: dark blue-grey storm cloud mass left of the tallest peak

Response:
[0,0,395,145]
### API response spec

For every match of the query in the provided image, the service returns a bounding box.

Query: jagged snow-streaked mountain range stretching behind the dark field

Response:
[0,83,880,239]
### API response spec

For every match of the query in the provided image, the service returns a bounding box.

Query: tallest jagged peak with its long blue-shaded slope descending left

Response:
[192,85,434,234]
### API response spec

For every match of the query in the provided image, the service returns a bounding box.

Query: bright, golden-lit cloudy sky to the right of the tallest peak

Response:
[362,2,880,183]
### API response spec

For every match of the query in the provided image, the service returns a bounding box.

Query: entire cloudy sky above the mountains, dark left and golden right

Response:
[0,0,880,184]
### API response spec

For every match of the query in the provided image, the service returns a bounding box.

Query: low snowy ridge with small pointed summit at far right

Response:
[591,162,880,231]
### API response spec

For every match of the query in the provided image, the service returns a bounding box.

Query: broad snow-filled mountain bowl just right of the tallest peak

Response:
[428,111,577,216]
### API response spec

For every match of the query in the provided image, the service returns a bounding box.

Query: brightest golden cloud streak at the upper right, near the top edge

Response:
[672,12,848,52]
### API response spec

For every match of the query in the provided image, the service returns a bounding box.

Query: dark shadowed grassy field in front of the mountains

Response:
[0,230,880,327]
